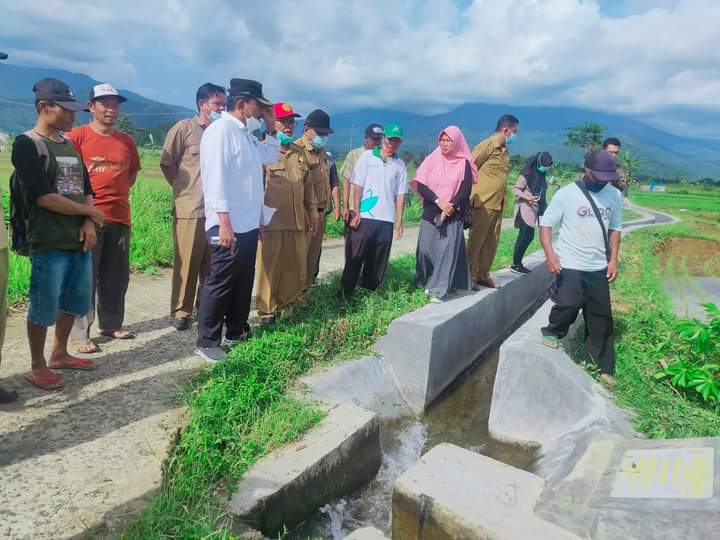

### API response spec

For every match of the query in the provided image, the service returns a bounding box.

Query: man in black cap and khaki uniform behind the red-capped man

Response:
[295,109,334,298]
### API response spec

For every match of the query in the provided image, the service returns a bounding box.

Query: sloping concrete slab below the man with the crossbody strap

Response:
[488,302,635,450]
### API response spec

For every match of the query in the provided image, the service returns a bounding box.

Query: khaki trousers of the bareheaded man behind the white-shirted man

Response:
[170,218,210,319]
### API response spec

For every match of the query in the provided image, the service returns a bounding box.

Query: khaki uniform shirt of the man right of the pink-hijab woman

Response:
[470,134,510,210]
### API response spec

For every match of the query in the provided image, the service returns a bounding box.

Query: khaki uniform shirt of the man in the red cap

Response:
[265,143,318,231]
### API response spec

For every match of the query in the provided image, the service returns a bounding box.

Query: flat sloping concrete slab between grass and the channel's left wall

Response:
[300,356,412,418]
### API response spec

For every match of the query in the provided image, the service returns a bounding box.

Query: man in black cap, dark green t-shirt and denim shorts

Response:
[12,79,105,390]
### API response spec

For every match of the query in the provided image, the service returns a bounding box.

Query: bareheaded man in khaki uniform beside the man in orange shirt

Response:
[160,83,225,330]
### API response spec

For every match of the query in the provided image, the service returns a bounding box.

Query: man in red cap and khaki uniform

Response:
[255,102,318,323]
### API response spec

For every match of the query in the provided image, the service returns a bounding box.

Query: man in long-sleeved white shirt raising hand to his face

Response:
[195,79,280,362]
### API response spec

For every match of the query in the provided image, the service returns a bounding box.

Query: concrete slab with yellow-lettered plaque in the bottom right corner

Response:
[536,438,720,540]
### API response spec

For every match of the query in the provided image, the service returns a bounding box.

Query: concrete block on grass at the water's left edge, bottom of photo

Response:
[228,405,382,536]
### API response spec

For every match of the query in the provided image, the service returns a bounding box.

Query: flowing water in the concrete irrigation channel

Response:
[288,353,535,540]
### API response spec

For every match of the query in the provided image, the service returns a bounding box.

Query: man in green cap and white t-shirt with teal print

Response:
[340,124,407,298]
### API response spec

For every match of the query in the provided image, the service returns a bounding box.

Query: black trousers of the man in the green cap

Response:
[340,219,393,296]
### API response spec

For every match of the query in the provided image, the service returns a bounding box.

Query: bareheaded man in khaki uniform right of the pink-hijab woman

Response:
[467,114,519,290]
